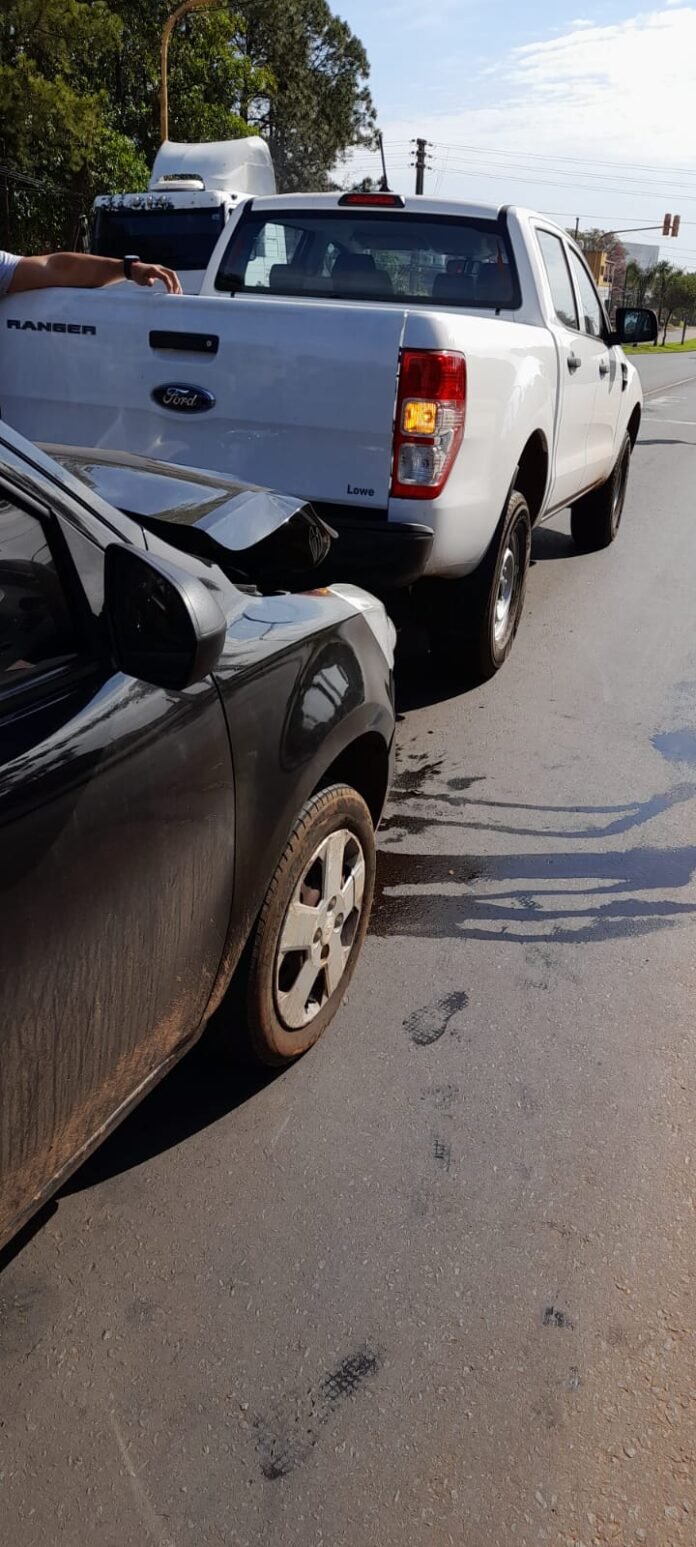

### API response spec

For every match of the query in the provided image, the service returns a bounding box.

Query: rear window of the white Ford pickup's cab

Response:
[215,207,520,311]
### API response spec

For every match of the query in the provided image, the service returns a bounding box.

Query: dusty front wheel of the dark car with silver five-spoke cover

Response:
[246,784,376,1067]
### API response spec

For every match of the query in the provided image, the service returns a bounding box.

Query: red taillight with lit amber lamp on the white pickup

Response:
[391,350,467,500]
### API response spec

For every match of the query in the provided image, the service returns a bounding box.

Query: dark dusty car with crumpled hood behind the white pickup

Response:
[0,425,394,1244]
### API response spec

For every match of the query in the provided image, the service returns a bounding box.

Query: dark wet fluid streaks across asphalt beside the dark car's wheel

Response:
[371,770,696,945]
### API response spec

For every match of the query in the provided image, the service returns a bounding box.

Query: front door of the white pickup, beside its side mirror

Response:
[568,248,623,483]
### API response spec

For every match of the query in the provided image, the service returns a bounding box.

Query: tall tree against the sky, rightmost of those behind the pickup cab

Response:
[237,0,374,192]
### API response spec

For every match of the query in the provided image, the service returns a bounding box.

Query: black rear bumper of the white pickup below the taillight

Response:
[312,501,435,593]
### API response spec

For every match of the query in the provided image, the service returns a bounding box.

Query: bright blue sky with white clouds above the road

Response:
[340,0,696,269]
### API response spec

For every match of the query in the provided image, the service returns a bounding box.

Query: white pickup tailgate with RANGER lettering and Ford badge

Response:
[0,289,405,509]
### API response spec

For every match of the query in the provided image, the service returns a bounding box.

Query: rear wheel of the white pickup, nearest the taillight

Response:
[430,489,532,682]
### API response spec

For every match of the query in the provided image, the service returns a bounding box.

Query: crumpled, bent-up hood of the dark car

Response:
[42,446,326,554]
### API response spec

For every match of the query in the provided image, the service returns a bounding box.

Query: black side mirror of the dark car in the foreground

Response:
[104,543,227,692]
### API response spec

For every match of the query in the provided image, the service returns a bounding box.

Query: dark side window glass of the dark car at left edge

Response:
[0,497,77,693]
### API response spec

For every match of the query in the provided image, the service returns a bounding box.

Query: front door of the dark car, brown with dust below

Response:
[0,476,234,1241]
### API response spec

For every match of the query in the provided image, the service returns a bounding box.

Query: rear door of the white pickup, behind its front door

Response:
[537,226,599,507]
